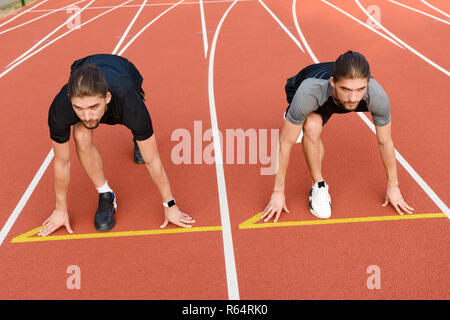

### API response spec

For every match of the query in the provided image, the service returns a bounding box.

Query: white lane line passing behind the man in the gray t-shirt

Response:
[292,0,450,218]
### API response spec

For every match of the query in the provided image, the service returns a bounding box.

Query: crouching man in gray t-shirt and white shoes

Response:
[261,51,414,221]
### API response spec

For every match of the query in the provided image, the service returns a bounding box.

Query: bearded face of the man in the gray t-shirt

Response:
[330,77,369,110]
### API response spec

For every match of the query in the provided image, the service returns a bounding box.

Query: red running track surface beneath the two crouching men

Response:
[0,0,450,299]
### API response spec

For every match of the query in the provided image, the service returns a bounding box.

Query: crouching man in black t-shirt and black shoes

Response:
[38,54,195,236]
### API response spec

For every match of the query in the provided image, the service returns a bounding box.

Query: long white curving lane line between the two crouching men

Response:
[208,0,239,300]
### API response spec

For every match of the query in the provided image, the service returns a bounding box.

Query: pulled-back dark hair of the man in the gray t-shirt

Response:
[333,50,370,82]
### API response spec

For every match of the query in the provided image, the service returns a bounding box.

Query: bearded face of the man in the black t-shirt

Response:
[71,92,111,129]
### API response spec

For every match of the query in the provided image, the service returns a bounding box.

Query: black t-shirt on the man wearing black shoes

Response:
[48,54,153,143]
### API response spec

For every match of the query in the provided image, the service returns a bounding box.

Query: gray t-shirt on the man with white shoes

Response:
[286,64,391,127]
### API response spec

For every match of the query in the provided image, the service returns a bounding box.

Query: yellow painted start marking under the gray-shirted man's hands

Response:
[239,212,447,229]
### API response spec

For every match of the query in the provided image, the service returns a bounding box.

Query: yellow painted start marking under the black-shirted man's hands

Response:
[11,226,222,243]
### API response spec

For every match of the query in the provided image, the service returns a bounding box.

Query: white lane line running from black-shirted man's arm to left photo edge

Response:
[0,149,53,246]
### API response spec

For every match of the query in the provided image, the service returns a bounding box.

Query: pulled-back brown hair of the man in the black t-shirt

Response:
[67,64,108,98]
